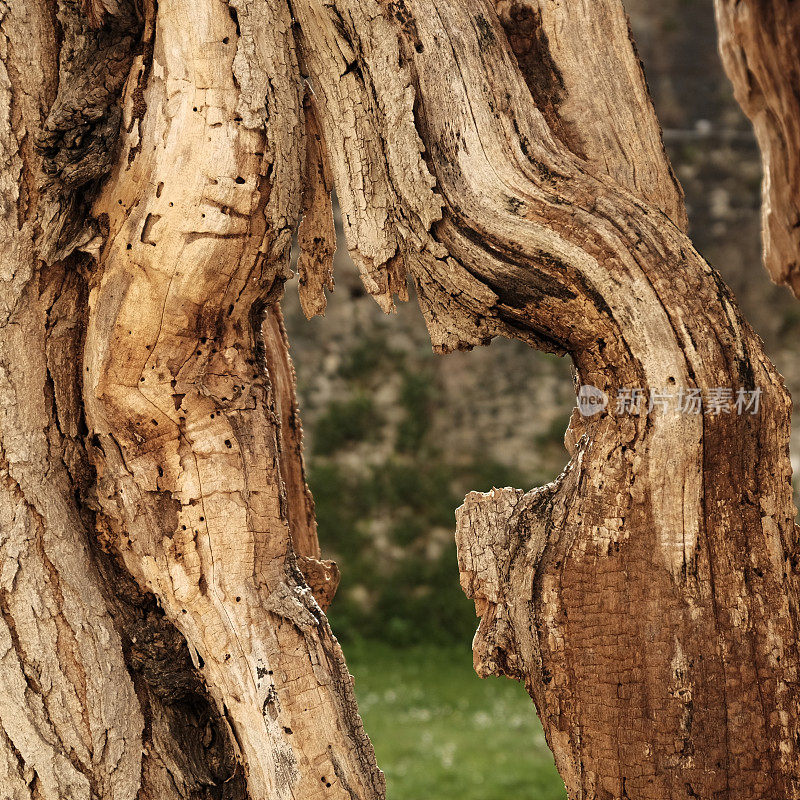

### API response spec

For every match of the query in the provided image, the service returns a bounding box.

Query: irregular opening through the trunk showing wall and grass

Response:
[282,198,575,800]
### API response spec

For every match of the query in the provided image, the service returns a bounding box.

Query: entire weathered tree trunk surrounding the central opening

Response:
[0,0,800,800]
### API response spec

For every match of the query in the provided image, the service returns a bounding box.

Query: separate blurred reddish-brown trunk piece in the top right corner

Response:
[714,0,800,297]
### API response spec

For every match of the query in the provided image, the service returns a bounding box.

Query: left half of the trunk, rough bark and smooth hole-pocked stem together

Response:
[0,0,383,800]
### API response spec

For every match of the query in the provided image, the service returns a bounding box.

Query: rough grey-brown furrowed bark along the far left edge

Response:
[0,2,144,800]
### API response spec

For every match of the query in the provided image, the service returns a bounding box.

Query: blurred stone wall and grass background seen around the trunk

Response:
[283,0,800,800]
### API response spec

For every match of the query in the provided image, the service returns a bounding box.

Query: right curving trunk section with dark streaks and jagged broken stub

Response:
[293,0,800,800]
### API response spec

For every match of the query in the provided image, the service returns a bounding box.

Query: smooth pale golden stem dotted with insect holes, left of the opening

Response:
[83,0,384,800]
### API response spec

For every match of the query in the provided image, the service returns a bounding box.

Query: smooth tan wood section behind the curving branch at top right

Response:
[496,0,688,231]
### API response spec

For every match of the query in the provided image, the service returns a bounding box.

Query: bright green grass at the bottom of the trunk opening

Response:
[344,641,566,800]
